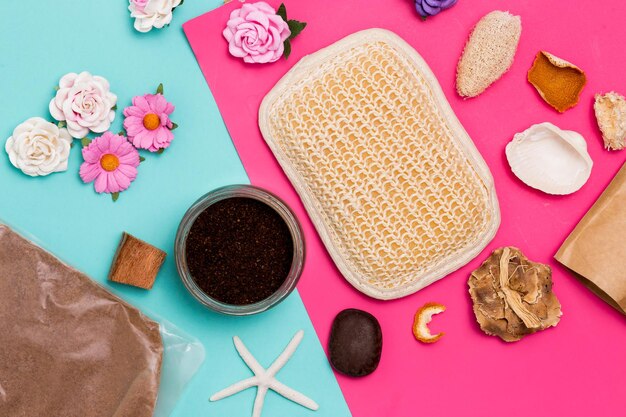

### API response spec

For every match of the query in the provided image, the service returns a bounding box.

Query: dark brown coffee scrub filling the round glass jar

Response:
[185,197,294,305]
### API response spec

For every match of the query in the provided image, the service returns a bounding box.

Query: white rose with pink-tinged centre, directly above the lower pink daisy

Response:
[49,71,117,138]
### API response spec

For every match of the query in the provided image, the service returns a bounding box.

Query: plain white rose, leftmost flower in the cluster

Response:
[4,117,72,177]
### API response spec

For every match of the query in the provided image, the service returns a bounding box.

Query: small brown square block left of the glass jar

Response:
[109,232,165,290]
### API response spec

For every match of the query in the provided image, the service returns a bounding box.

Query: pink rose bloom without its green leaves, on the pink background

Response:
[222,1,291,64]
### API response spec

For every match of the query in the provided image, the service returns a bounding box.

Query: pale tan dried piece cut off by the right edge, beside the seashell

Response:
[593,91,626,150]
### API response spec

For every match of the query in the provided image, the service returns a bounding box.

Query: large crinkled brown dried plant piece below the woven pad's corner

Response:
[468,247,562,342]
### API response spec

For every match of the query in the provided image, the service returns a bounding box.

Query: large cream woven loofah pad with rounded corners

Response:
[259,29,500,299]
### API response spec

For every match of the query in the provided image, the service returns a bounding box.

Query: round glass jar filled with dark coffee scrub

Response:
[175,185,305,315]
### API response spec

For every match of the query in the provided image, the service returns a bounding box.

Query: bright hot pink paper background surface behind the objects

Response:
[184,0,626,417]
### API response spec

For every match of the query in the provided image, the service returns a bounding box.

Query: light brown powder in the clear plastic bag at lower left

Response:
[0,225,163,417]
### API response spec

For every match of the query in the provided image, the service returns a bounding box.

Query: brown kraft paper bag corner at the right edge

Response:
[555,164,626,315]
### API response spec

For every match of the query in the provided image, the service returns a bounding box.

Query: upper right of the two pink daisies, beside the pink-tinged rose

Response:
[124,94,174,152]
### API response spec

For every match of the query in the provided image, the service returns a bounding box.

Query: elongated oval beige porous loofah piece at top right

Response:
[456,10,522,97]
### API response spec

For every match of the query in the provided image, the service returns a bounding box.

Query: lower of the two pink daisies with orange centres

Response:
[80,132,139,193]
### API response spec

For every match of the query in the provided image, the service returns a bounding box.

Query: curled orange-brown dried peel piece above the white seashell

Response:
[528,51,587,113]
